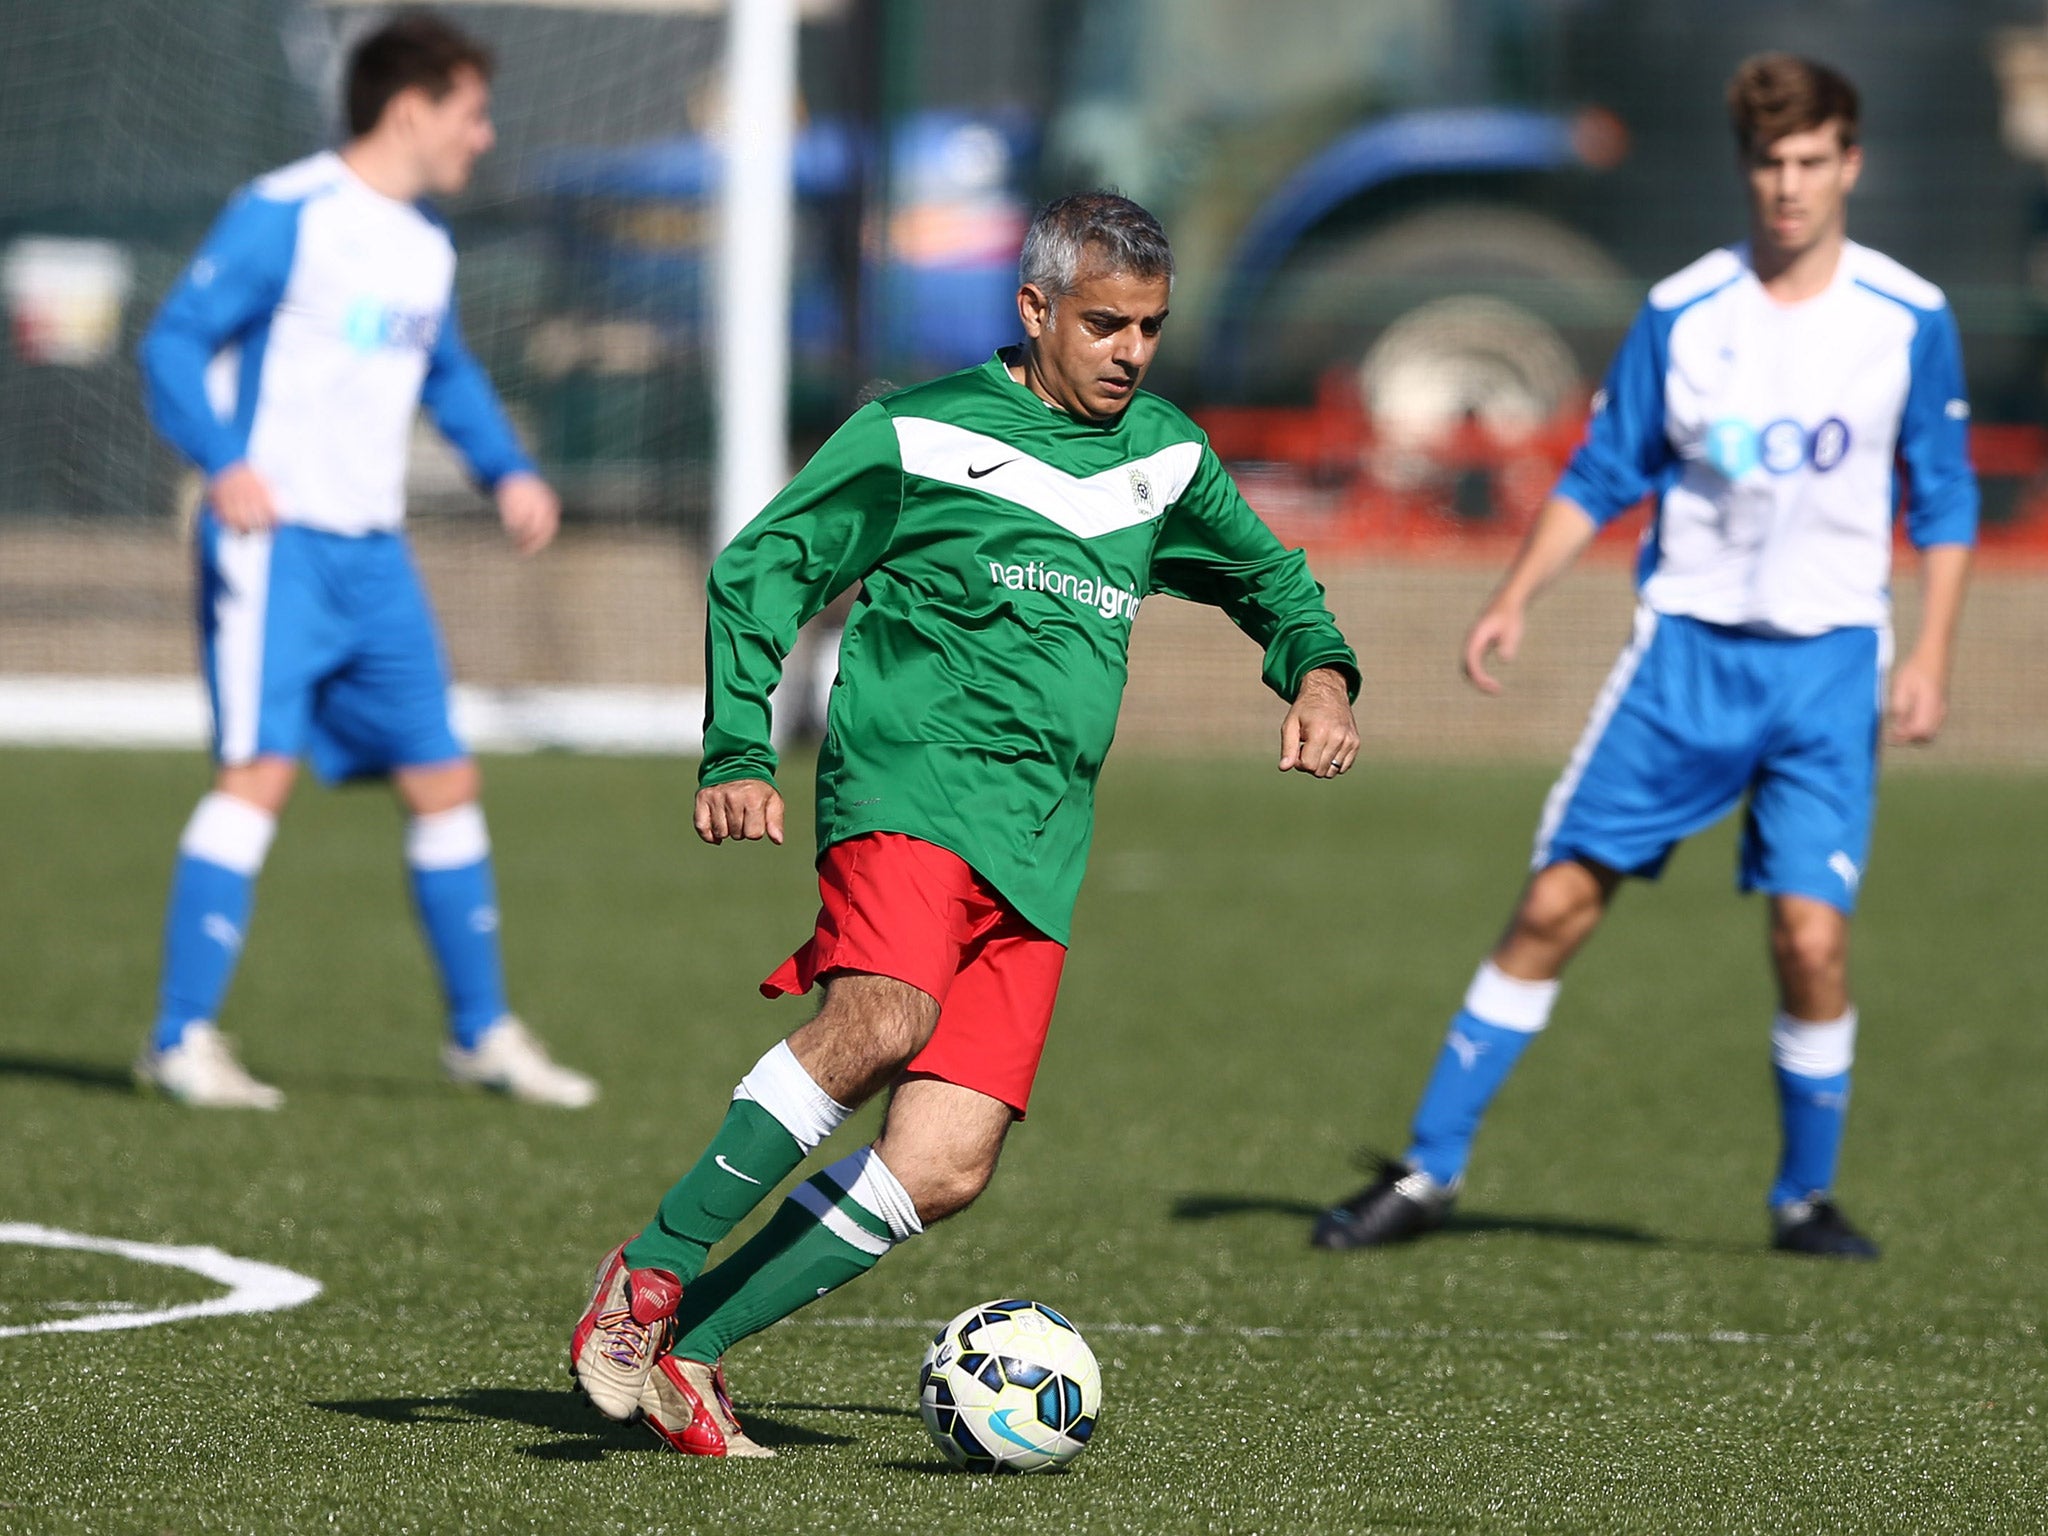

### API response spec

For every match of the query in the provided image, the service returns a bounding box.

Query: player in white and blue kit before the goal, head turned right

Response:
[135,14,596,1108]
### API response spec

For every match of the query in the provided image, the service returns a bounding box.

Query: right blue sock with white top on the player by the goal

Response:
[406,805,508,1051]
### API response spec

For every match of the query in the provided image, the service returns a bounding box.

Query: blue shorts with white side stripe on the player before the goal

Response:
[199,514,465,782]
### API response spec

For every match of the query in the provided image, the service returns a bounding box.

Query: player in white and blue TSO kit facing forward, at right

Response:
[1315,53,1978,1257]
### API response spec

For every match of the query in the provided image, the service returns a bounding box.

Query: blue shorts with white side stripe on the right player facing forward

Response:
[1532,608,1890,911]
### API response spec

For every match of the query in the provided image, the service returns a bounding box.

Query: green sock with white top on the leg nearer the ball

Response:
[672,1153,909,1362]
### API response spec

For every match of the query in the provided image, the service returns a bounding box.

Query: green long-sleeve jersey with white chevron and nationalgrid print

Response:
[698,354,1358,942]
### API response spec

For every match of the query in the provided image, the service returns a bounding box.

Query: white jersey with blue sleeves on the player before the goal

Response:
[141,152,532,535]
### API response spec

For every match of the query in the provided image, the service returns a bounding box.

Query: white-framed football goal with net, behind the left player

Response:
[0,0,811,754]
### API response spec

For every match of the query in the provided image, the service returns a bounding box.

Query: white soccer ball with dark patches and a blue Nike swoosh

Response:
[918,1300,1102,1473]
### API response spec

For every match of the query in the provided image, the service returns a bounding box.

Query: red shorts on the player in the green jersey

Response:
[762,831,1067,1118]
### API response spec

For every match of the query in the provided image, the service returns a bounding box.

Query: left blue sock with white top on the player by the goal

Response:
[150,793,276,1051]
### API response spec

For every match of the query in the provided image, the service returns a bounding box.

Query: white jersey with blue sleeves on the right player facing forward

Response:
[1556,242,1978,635]
